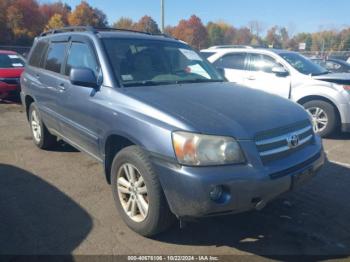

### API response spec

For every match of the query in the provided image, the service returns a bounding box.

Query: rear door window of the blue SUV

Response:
[45,43,67,73]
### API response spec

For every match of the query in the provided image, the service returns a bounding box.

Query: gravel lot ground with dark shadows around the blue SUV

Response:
[0,103,350,259]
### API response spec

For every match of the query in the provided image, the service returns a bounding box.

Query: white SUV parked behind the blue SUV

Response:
[201,48,350,137]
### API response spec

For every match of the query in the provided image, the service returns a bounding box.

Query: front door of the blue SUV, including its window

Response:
[59,36,101,158]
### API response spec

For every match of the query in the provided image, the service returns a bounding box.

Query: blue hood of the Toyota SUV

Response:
[124,82,308,139]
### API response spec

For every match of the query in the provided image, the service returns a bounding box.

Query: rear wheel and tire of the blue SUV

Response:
[29,103,57,149]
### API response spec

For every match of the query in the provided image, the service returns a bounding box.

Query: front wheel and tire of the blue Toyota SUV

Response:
[111,146,175,237]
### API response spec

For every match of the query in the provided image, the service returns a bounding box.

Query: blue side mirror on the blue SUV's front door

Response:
[69,67,98,88]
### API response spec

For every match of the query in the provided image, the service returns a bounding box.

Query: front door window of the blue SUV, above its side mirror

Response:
[65,42,99,75]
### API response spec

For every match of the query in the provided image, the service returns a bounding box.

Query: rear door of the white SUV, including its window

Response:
[214,52,248,85]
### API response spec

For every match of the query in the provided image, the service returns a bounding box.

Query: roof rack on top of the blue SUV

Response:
[40,26,170,38]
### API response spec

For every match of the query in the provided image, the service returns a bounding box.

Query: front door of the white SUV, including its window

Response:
[245,53,291,98]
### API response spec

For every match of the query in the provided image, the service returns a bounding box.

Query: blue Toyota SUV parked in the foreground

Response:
[21,27,324,236]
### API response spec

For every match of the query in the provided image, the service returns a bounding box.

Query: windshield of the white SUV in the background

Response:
[280,53,328,76]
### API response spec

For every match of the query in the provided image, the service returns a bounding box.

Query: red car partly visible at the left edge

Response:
[0,50,25,99]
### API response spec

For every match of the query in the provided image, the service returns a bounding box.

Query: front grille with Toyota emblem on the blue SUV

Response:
[255,121,314,164]
